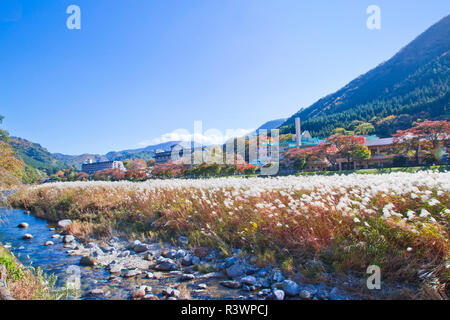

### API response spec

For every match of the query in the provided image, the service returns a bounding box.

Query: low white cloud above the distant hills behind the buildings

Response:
[138,128,255,147]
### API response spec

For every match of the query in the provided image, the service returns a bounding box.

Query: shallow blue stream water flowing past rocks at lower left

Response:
[0,208,251,299]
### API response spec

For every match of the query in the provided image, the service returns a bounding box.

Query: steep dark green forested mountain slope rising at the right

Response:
[281,15,450,136]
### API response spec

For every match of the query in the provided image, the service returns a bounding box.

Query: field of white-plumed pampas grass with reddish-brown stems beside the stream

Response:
[4,172,450,298]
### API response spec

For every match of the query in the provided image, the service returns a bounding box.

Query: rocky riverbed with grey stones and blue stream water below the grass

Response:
[0,209,368,300]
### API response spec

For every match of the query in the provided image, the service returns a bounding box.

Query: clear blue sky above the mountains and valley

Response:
[0,0,450,154]
